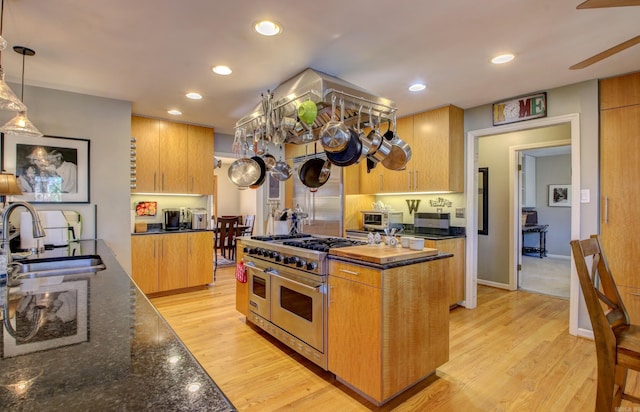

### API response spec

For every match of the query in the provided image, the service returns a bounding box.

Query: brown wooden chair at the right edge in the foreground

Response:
[570,235,640,412]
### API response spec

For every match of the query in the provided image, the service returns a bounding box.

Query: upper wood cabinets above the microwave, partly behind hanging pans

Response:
[360,105,464,194]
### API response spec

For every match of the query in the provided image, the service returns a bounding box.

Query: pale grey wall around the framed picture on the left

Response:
[0,84,131,270]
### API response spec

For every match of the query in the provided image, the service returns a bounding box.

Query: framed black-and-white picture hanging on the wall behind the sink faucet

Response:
[2,134,90,203]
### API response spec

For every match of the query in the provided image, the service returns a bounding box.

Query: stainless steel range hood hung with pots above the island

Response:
[236,68,396,143]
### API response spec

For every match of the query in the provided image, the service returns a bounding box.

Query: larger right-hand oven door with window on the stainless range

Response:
[270,270,326,353]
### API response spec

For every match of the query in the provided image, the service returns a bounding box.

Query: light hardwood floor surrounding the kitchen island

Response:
[152,268,640,412]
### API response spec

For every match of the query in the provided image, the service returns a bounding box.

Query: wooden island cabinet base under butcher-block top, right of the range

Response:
[327,259,449,404]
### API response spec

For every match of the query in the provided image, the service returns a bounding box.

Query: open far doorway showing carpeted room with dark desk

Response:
[514,141,571,299]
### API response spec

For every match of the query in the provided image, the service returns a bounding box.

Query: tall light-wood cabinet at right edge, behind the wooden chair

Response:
[600,72,640,323]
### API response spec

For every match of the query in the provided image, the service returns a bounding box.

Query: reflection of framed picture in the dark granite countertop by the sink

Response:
[2,276,89,358]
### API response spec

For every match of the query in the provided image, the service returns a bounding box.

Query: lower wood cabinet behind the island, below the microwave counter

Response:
[424,237,465,306]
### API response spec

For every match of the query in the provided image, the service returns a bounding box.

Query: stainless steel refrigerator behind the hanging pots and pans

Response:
[293,153,344,236]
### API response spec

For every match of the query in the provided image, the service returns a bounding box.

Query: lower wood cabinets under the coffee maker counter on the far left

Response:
[131,231,213,294]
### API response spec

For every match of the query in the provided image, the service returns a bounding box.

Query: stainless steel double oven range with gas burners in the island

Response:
[242,233,366,370]
